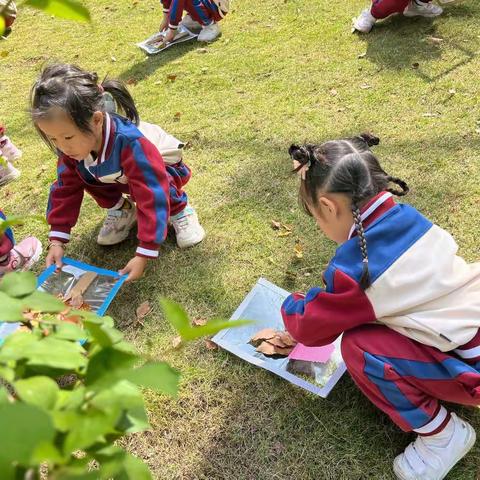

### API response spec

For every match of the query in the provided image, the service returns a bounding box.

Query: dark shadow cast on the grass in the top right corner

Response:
[362,4,478,82]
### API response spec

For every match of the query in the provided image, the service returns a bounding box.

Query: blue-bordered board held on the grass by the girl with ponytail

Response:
[0,257,127,345]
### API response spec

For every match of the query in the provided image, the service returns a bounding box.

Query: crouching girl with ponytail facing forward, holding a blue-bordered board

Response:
[31,64,205,280]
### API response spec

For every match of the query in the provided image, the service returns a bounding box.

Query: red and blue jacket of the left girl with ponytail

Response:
[47,113,183,258]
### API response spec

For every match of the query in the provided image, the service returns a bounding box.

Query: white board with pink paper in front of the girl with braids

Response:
[213,278,346,398]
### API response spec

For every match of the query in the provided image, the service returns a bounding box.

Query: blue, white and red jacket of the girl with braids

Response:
[282,192,480,351]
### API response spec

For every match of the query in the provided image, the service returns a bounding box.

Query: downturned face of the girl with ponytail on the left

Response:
[37,112,103,161]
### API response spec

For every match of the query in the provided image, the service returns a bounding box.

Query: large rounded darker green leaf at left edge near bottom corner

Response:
[0,402,55,465]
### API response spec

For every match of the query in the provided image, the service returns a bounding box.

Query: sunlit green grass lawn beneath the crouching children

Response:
[0,0,480,480]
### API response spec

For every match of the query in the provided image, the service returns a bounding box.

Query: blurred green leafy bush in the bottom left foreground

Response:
[0,272,246,480]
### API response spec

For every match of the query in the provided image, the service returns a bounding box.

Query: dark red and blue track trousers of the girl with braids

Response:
[342,325,480,435]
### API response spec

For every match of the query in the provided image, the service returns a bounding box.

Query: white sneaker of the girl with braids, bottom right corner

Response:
[393,413,476,480]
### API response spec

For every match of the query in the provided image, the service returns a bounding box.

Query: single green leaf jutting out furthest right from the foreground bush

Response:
[124,362,180,396]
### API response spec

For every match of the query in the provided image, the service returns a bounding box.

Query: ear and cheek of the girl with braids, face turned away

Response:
[309,193,353,244]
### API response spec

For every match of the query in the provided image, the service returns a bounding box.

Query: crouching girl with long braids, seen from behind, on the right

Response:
[282,134,480,480]
